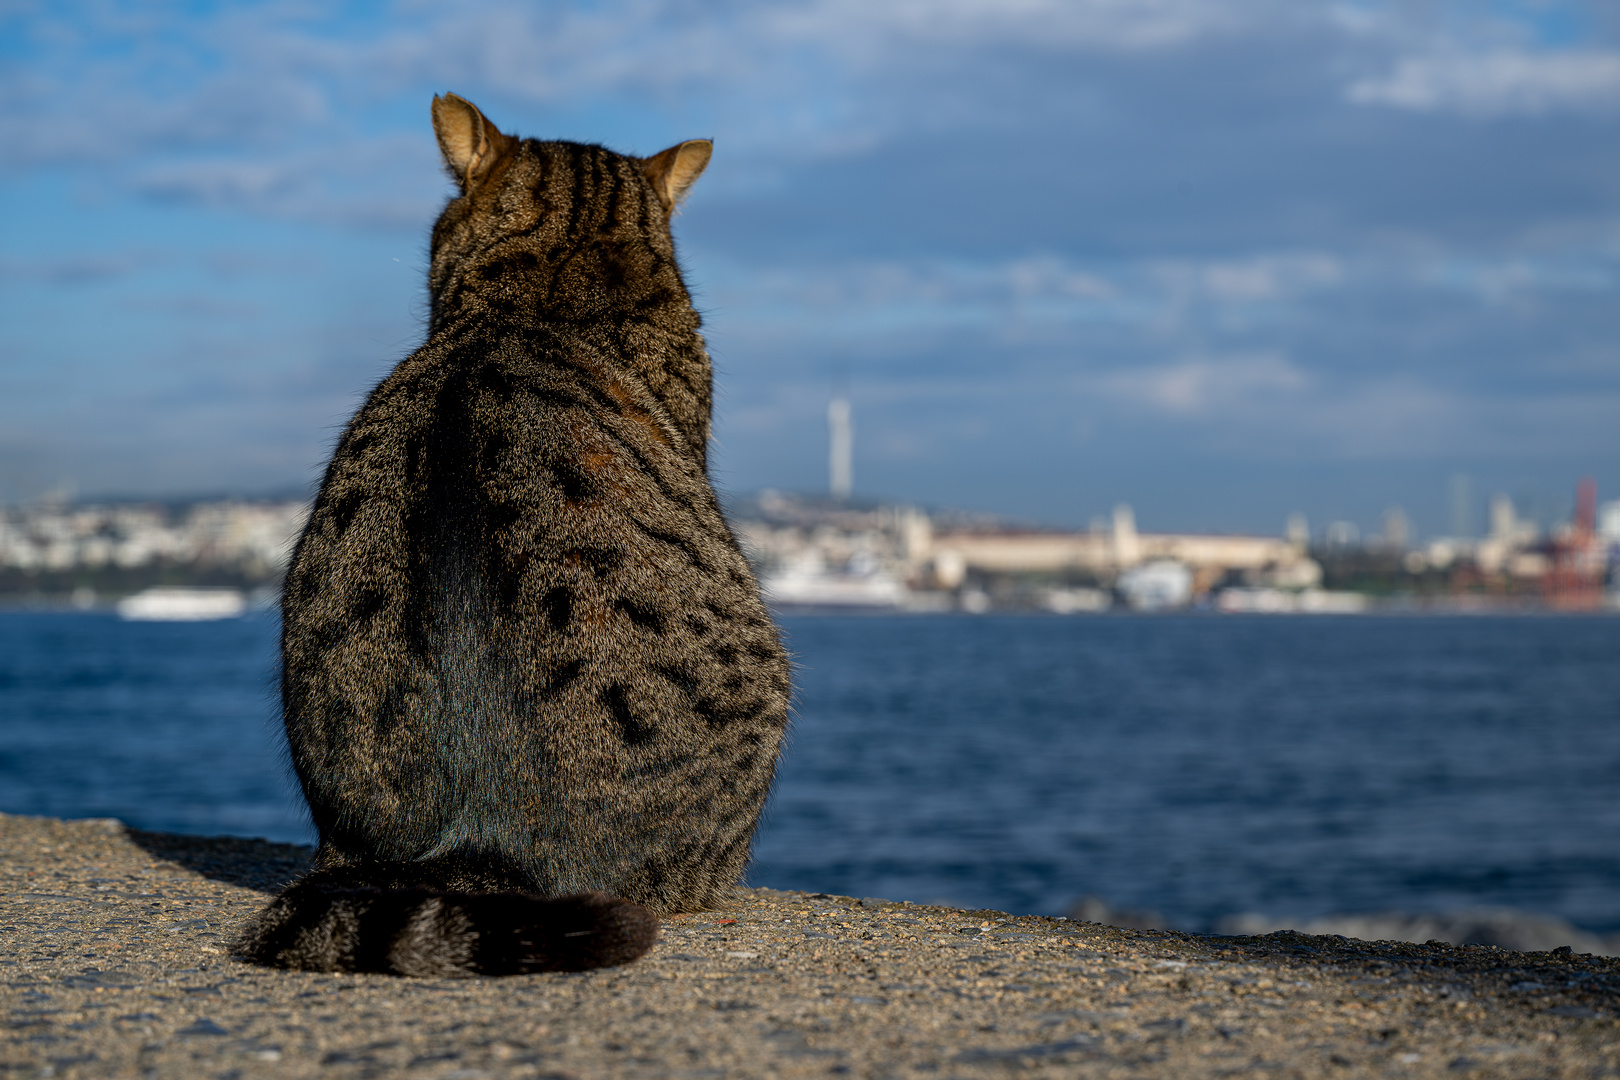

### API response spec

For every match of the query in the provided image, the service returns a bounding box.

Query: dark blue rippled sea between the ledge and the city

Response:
[0,612,1620,933]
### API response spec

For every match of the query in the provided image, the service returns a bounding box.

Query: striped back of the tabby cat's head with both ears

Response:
[428,94,713,322]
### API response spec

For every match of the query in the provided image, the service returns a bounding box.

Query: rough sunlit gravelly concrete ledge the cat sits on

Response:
[0,814,1620,1080]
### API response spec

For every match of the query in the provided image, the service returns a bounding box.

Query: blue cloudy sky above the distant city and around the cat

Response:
[0,0,1620,536]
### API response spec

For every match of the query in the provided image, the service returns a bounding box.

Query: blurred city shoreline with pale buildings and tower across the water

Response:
[0,488,1620,620]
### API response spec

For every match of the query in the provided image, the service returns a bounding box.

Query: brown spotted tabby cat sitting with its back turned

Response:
[237,94,789,976]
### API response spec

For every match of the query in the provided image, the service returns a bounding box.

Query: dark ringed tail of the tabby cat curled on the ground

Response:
[235,863,658,978]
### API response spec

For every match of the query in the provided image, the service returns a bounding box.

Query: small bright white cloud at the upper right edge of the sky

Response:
[1345,49,1620,117]
